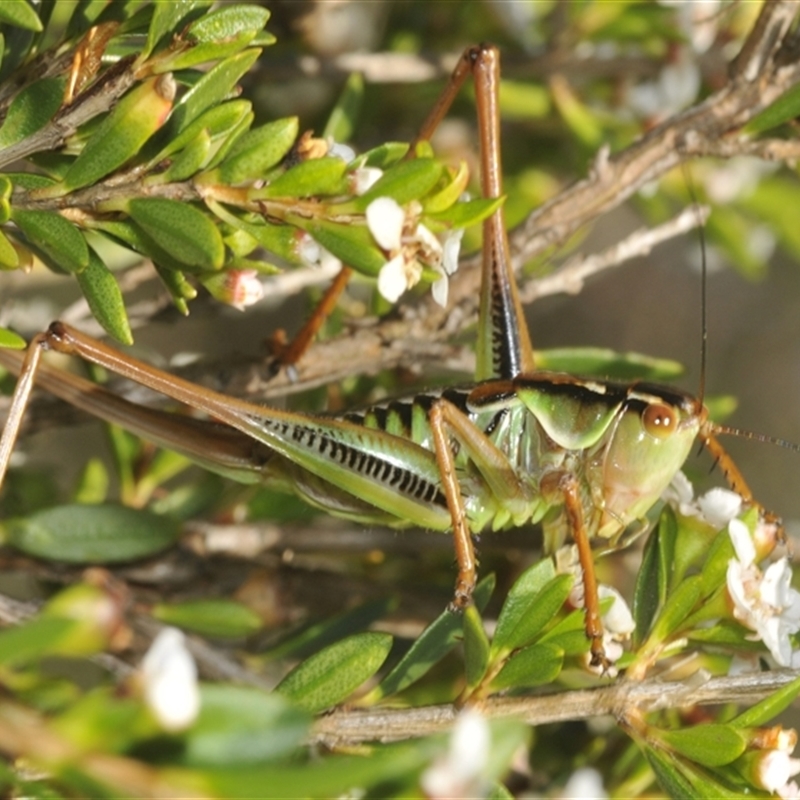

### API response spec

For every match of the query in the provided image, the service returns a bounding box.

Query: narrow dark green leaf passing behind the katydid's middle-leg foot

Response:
[367,575,495,702]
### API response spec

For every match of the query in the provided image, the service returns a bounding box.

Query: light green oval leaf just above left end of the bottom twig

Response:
[275,633,392,713]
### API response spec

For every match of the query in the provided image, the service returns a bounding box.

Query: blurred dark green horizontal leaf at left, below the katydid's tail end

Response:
[0,505,180,564]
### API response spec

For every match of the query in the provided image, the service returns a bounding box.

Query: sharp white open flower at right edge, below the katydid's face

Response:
[727,519,800,667]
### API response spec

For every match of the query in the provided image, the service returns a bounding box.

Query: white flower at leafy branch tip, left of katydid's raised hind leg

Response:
[366,197,464,306]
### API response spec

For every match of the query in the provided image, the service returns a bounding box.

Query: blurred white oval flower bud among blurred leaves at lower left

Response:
[141,628,200,731]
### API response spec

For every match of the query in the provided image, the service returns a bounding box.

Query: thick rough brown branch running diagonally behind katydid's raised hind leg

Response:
[170,0,800,398]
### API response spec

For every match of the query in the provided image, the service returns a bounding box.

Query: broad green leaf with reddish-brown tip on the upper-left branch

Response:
[61,74,175,192]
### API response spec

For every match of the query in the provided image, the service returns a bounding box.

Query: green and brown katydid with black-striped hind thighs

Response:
[0,46,780,666]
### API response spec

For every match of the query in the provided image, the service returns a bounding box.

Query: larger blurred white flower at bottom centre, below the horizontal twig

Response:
[420,708,490,800]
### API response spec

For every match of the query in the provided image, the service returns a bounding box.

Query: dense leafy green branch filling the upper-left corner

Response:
[0,0,484,346]
